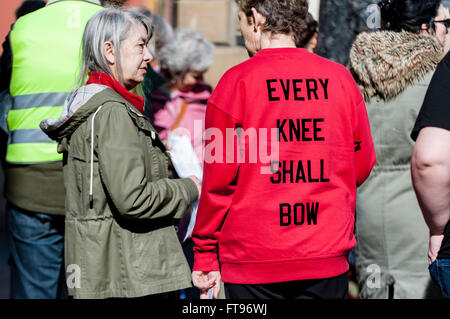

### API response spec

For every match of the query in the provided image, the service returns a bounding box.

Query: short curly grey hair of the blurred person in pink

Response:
[160,28,214,77]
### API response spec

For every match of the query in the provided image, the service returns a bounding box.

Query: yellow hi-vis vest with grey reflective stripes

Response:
[6,0,102,164]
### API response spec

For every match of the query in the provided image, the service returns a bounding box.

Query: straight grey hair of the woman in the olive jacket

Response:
[77,8,153,87]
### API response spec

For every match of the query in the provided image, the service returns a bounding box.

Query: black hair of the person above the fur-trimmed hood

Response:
[378,0,442,33]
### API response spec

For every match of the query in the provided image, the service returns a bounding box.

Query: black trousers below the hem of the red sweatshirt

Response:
[225,273,348,299]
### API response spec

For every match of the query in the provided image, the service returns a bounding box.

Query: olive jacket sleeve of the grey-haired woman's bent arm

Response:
[95,104,199,219]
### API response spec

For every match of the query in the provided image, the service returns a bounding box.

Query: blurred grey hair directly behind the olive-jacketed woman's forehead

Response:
[130,6,174,60]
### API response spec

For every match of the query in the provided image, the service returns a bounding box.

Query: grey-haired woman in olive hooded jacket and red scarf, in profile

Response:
[41,9,200,298]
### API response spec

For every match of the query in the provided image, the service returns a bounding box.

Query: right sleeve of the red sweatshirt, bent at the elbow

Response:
[353,97,376,186]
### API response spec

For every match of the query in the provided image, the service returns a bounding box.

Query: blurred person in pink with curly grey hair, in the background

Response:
[152,29,214,299]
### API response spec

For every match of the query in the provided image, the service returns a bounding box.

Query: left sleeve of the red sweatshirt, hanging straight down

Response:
[192,103,239,271]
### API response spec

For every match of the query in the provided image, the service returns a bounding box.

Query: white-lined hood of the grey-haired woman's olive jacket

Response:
[39,84,108,141]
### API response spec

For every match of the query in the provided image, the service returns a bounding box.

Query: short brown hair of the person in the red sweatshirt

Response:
[235,0,308,43]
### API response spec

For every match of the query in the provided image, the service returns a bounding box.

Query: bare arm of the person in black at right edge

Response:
[411,127,450,262]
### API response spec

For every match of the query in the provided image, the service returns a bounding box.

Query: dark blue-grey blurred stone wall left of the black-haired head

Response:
[317,0,378,65]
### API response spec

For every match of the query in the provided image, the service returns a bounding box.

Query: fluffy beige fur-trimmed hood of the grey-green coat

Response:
[349,31,443,102]
